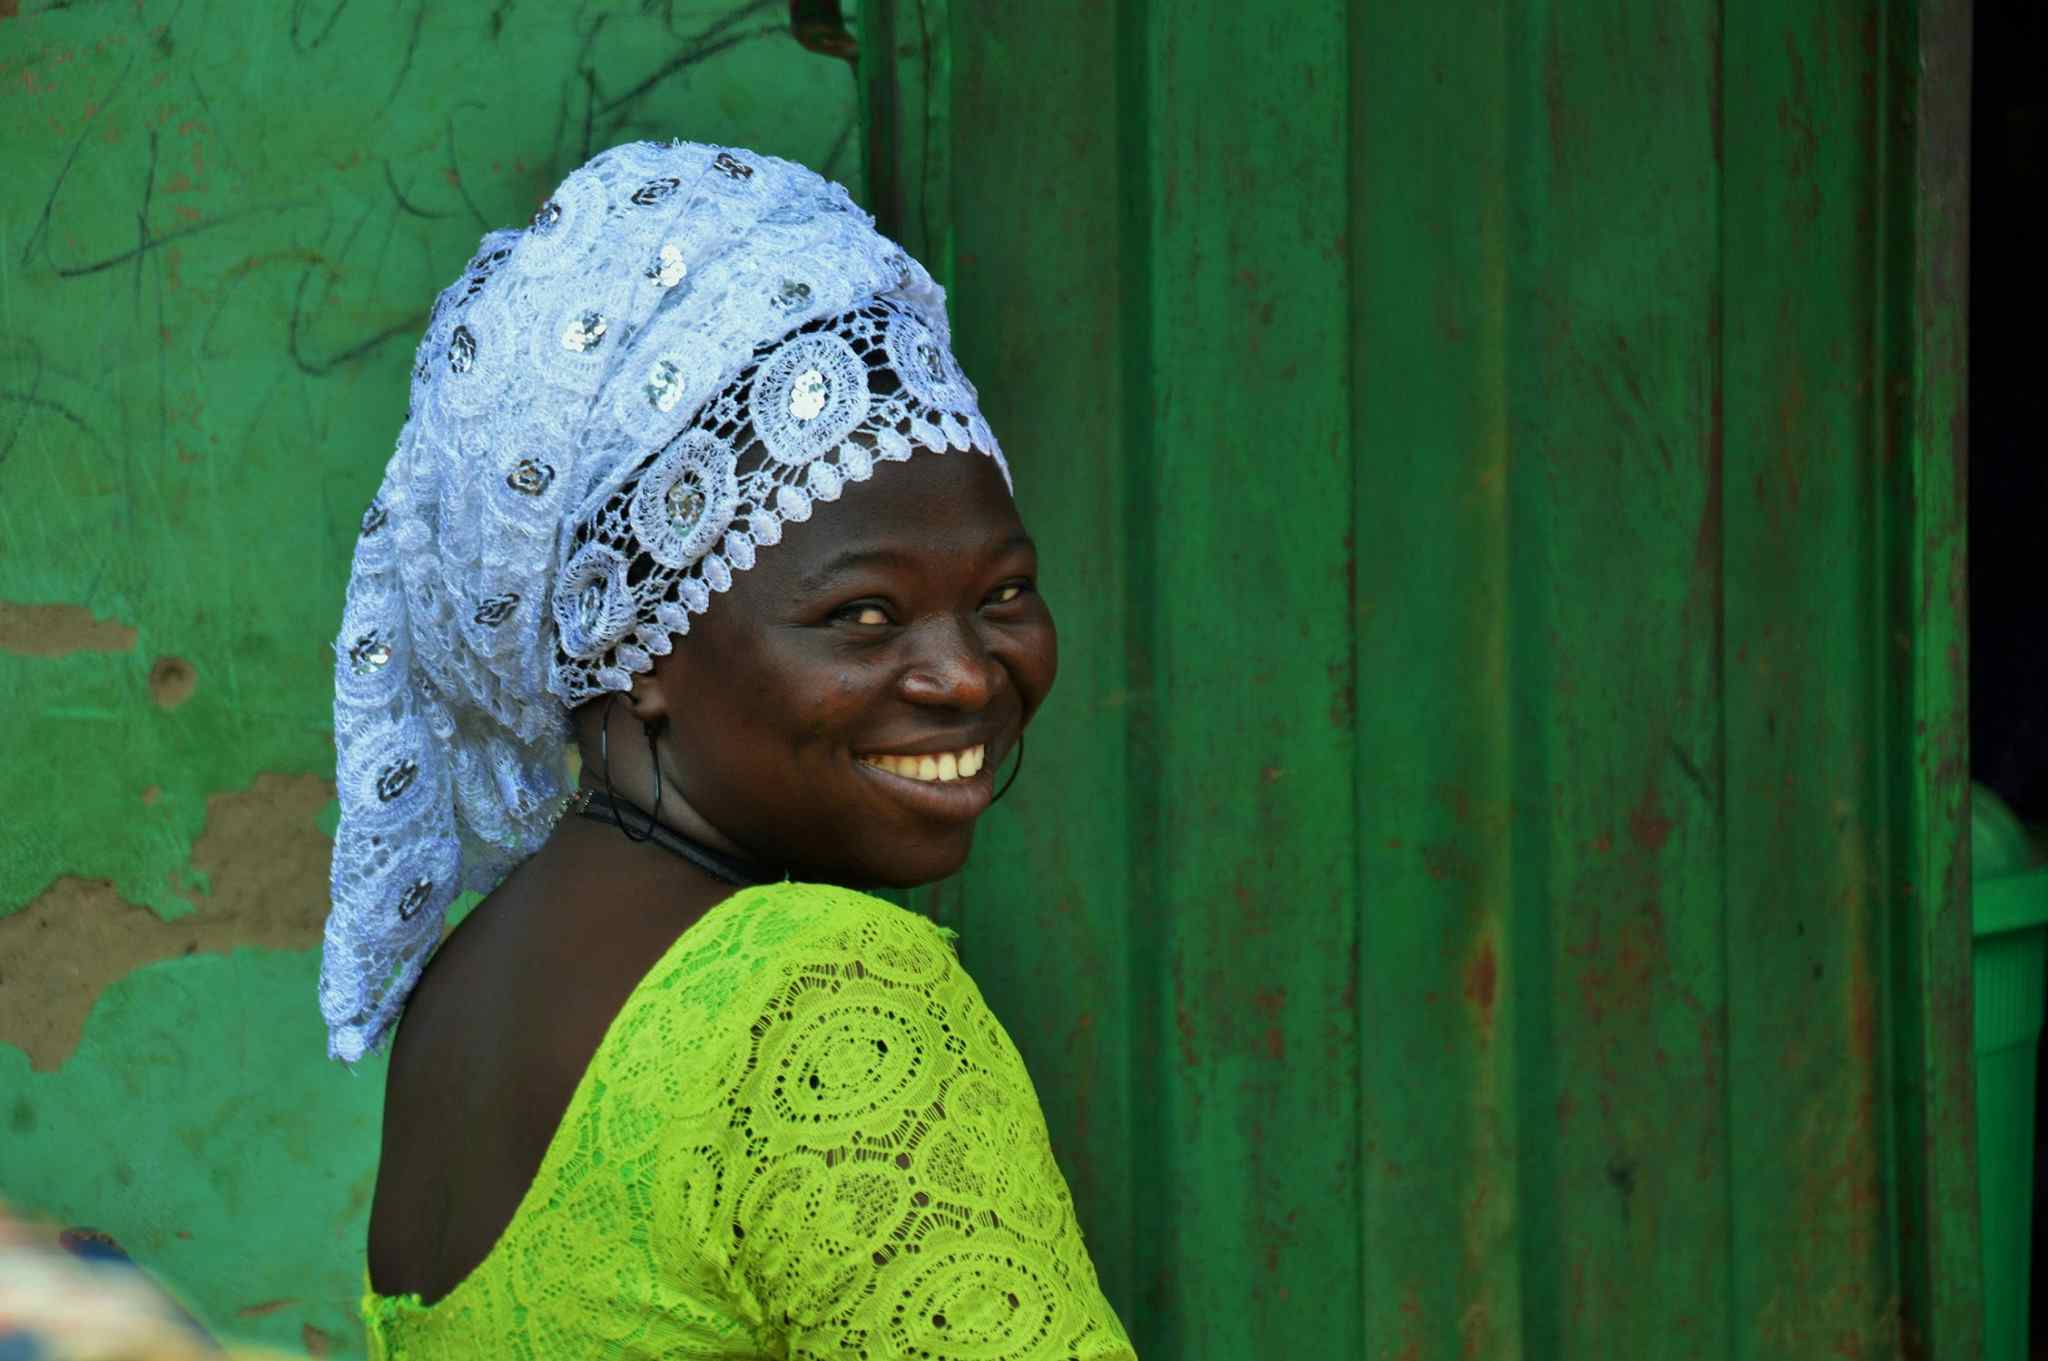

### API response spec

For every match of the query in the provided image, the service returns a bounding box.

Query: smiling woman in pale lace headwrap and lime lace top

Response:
[322,143,1133,1361]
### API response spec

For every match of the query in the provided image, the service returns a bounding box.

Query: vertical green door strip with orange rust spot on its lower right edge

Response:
[1350,6,1522,1357]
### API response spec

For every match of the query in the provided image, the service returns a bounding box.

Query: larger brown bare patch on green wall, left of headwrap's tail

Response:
[0,776,334,1072]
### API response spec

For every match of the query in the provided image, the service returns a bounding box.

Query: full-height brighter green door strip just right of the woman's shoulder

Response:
[1120,4,1358,1355]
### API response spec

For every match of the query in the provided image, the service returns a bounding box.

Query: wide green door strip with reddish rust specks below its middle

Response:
[1505,4,1726,1357]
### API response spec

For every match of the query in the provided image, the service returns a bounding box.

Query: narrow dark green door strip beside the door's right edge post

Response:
[1724,4,1898,1357]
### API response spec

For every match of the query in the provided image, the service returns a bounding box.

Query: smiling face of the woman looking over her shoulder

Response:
[653,452,1059,886]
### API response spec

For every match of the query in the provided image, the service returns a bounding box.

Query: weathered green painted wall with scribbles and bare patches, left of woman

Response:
[0,0,860,1355]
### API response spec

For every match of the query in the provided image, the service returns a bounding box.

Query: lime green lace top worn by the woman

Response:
[362,884,1135,1361]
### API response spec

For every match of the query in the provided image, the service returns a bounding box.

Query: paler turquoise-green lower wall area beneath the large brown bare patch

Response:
[0,950,383,1355]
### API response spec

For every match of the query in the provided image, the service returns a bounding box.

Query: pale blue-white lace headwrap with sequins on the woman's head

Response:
[319,141,1010,1062]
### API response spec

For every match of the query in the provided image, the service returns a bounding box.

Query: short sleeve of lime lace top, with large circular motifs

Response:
[635,884,1135,1361]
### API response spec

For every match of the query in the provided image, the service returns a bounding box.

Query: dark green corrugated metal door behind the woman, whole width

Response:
[862,0,1978,1361]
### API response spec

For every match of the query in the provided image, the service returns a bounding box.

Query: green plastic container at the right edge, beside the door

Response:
[1970,786,2048,1361]
